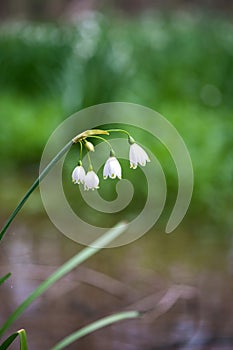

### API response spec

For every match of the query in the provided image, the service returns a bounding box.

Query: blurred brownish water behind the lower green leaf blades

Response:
[0,181,233,350]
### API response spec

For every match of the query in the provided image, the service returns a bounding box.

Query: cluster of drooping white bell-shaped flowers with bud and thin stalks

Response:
[72,129,150,191]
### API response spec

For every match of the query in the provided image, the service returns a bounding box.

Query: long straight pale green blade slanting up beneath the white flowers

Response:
[0,222,127,337]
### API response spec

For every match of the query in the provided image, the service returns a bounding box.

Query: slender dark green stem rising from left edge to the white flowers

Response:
[0,140,74,241]
